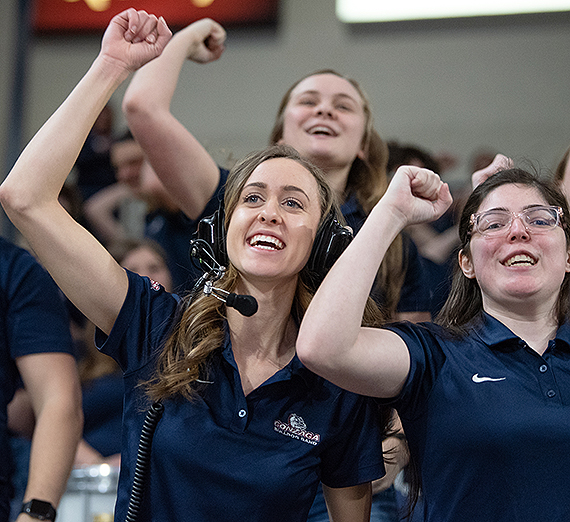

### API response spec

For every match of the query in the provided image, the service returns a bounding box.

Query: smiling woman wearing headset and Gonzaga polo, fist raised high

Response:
[0,9,385,522]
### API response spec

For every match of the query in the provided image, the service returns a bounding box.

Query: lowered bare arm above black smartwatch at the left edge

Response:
[16,352,83,506]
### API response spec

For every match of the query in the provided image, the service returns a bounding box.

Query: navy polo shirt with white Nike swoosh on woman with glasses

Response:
[388,314,570,522]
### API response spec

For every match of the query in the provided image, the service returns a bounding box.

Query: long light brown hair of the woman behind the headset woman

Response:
[269,69,406,315]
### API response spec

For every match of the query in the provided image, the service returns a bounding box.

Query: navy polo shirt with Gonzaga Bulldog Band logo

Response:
[98,272,384,522]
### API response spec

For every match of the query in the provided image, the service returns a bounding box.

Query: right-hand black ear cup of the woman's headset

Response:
[307,212,353,290]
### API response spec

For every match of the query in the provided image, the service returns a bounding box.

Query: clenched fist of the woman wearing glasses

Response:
[380,166,453,227]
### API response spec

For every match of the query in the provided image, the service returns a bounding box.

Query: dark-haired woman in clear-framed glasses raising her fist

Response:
[297,167,570,522]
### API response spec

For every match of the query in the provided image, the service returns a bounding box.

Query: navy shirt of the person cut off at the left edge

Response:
[0,238,73,519]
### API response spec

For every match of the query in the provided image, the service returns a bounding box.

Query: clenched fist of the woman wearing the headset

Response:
[101,8,172,72]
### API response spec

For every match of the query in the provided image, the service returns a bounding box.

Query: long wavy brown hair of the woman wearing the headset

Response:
[145,145,384,400]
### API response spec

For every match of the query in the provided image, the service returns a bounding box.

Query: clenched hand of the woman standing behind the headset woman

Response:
[181,18,226,63]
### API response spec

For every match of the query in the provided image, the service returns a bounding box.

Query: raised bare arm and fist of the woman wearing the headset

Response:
[0,9,170,333]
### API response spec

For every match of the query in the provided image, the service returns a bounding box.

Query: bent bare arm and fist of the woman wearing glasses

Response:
[297,167,451,397]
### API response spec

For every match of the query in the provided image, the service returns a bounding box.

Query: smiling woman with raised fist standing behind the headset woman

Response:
[123,26,424,522]
